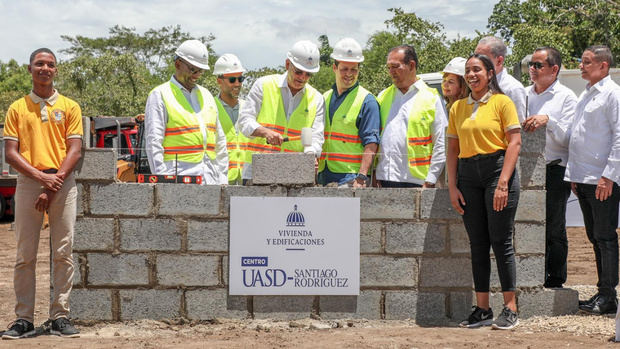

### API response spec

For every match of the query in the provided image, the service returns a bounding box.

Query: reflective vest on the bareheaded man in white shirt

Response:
[377,81,439,180]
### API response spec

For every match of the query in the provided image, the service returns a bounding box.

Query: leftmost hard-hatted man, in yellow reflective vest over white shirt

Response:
[144,40,228,184]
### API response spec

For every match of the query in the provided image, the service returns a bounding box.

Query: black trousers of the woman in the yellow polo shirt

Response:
[457,152,519,292]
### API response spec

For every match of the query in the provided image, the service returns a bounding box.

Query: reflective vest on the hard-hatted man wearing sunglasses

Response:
[214,98,248,184]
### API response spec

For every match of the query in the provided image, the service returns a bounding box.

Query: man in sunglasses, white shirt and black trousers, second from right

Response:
[523,46,577,288]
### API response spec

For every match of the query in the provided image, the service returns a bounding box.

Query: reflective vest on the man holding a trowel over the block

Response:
[246,75,323,163]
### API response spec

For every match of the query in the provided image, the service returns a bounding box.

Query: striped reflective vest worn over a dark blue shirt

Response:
[319,85,370,173]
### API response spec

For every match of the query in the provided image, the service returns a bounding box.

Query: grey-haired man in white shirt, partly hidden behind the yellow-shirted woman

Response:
[475,36,527,122]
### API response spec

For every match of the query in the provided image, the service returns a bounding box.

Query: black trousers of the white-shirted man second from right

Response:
[545,164,570,287]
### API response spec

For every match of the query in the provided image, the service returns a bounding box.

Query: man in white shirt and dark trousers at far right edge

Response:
[564,46,620,314]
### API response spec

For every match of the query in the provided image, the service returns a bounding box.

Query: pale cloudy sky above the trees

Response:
[0,0,497,69]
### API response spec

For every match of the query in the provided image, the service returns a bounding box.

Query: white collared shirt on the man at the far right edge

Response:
[564,75,620,184]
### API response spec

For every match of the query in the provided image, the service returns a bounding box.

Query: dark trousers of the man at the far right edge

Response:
[577,183,620,297]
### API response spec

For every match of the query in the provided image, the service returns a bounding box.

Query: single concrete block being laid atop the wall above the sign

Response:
[252,153,315,185]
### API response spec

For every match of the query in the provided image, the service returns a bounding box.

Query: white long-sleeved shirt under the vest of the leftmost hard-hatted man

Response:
[144,76,228,184]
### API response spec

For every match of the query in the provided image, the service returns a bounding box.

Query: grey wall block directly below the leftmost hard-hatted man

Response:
[155,183,221,216]
